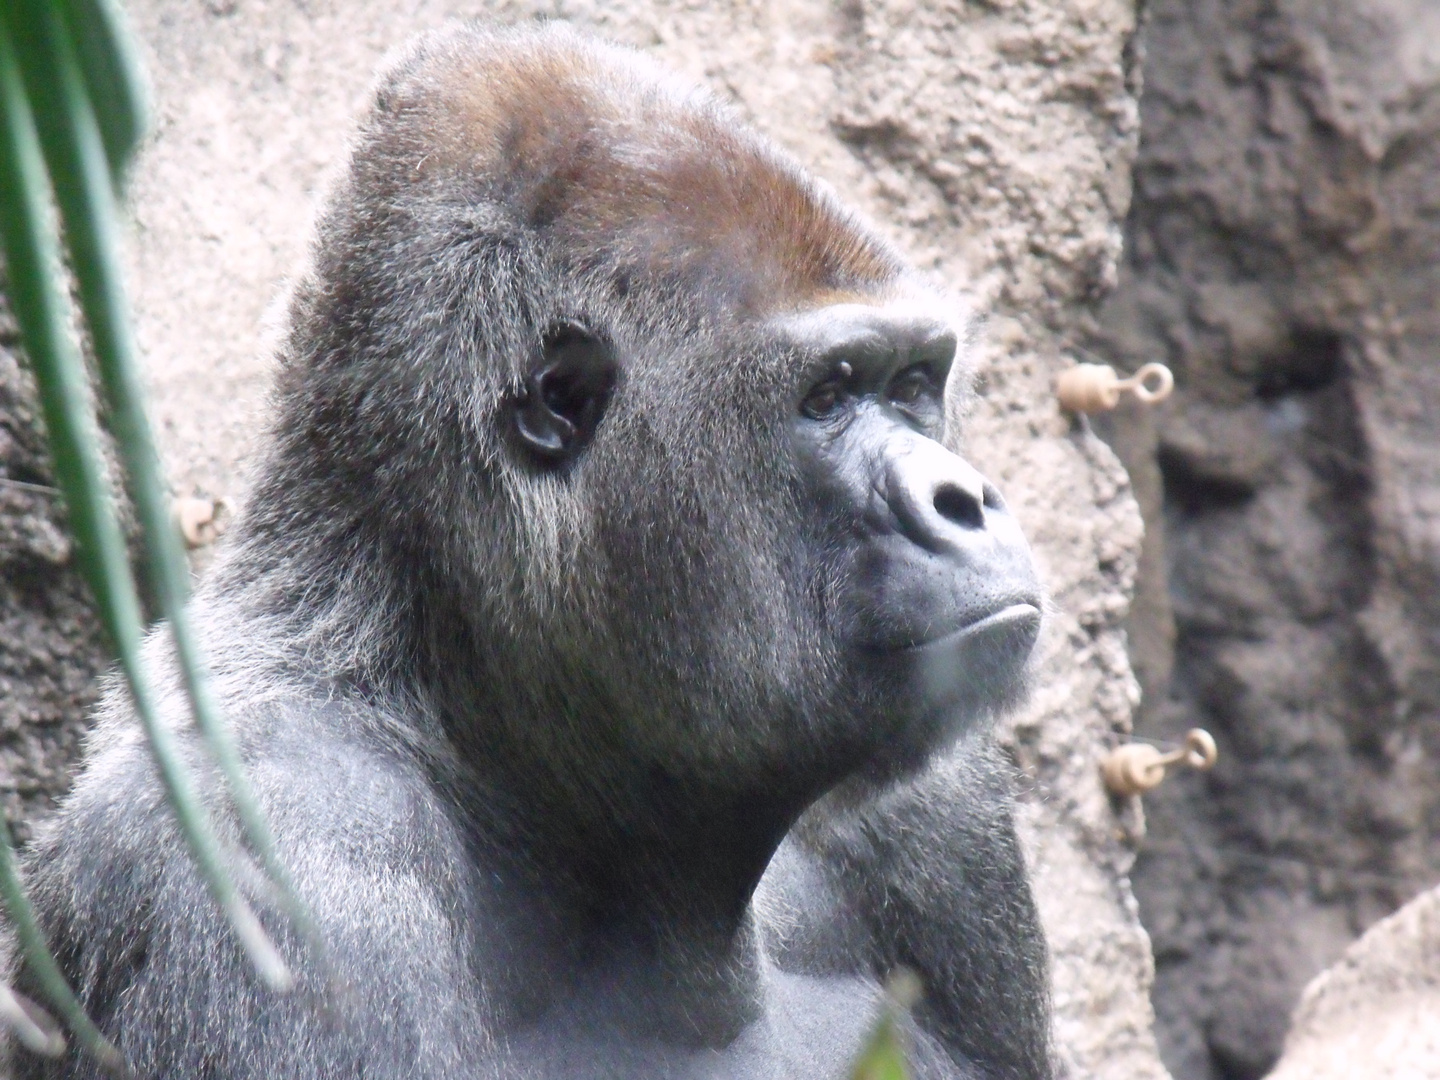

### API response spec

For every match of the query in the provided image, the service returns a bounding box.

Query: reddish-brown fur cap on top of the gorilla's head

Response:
[360,27,903,315]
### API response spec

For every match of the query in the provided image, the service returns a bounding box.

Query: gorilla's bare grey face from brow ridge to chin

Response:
[780,302,1041,770]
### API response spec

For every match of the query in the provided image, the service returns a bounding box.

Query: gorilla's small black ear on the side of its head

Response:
[516,321,619,465]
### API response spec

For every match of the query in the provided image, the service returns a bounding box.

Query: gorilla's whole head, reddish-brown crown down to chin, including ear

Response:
[227,29,1040,921]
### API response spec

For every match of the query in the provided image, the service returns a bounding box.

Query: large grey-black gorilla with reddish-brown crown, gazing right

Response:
[13,26,1053,1080]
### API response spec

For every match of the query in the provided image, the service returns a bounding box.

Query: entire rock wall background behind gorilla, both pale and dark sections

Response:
[0,0,1440,1080]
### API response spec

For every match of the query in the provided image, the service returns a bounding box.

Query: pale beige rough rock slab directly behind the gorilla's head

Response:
[2,0,1165,1080]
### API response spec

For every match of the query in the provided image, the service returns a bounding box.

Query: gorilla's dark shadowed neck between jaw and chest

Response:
[445,694,808,1045]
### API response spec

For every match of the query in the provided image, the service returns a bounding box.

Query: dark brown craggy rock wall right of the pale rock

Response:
[1096,0,1440,1080]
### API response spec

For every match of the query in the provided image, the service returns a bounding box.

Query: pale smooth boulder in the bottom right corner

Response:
[1269,890,1440,1080]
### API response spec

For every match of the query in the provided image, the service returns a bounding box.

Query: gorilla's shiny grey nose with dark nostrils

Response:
[887,439,1002,552]
